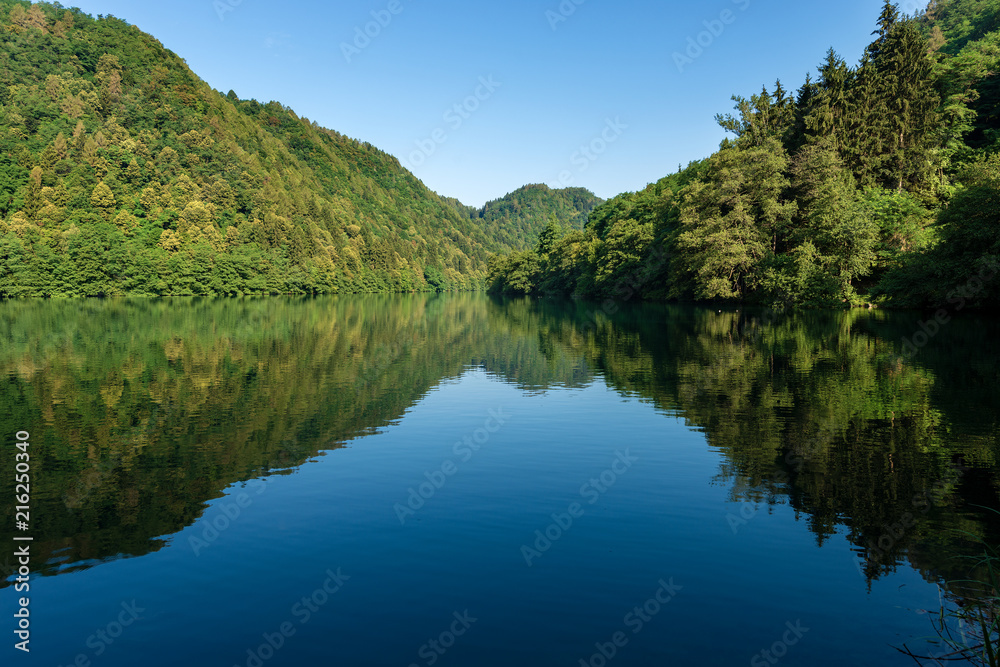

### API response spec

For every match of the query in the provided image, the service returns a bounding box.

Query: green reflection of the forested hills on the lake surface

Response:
[0,294,1000,596]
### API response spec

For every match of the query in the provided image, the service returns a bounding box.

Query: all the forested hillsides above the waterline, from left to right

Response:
[0,0,1000,310]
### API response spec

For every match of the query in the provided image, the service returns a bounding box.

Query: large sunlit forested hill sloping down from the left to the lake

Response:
[0,0,537,297]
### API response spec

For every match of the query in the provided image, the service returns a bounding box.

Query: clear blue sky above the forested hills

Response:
[68,0,917,206]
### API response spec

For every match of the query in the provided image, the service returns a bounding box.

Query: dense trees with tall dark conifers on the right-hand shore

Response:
[488,0,1000,310]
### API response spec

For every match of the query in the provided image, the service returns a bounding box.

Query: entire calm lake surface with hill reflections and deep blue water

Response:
[0,294,1000,667]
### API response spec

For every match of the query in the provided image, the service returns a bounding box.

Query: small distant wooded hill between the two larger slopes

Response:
[449,184,604,248]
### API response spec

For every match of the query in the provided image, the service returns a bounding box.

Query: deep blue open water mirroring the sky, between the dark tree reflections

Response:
[0,298,992,667]
